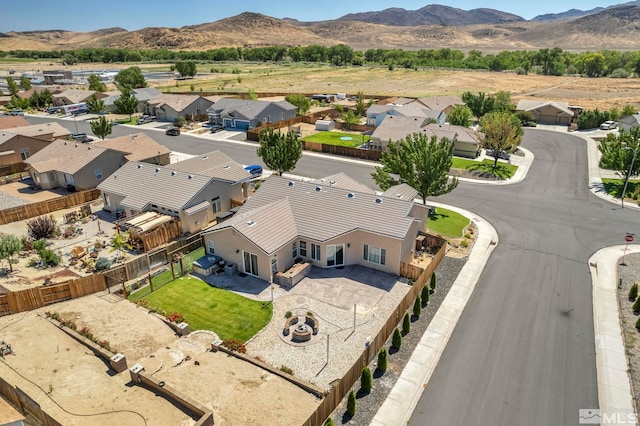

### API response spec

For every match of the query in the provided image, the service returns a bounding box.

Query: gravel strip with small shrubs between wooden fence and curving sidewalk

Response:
[324,257,464,426]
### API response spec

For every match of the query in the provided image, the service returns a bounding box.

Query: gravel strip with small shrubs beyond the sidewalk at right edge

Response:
[618,253,640,407]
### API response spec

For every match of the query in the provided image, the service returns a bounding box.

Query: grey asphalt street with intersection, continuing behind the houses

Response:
[29,118,640,426]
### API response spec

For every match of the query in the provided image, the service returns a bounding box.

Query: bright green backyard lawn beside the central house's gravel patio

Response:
[138,276,273,342]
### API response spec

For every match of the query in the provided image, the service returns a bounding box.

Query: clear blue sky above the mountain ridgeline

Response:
[0,0,625,32]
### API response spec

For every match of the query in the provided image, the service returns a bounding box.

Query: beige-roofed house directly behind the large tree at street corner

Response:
[369,115,480,158]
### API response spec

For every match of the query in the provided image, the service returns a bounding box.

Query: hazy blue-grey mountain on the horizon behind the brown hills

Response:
[337,4,524,26]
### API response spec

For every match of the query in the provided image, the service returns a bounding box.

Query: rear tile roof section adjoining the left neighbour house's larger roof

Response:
[170,151,251,182]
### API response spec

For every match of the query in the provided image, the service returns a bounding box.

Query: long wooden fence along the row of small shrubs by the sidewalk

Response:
[303,244,447,426]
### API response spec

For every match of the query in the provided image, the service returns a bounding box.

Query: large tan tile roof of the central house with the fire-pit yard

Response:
[209,176,414,253]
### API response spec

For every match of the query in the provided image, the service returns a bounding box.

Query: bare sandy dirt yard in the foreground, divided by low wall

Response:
[0,293,319,425]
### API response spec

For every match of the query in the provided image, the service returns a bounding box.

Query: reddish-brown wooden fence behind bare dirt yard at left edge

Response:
[0,274,107,316]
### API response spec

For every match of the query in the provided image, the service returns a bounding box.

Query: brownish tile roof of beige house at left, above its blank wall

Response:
[24,139,106,175]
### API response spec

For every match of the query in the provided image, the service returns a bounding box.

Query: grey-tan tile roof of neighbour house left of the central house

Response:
[97,161,212,210]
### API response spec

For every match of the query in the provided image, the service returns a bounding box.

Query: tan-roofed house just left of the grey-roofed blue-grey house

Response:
[144,93,213,122]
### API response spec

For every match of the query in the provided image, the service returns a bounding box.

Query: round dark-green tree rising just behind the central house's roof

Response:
[257,128,302,176]
